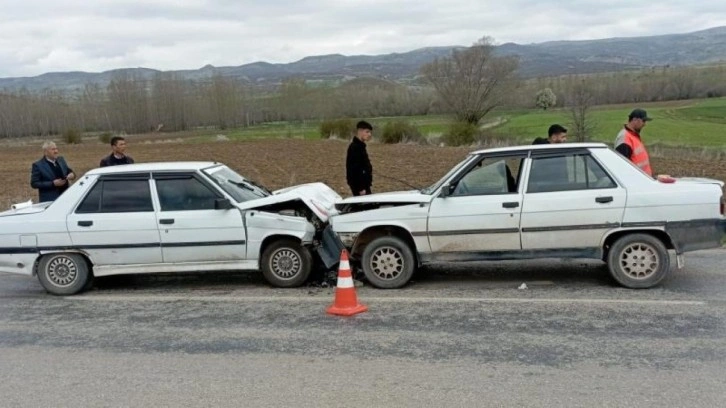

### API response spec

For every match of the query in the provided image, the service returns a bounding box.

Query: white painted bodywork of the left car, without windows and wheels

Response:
[0,162,340,276]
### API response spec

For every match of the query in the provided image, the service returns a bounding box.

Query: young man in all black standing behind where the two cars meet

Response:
[345,120,373,196]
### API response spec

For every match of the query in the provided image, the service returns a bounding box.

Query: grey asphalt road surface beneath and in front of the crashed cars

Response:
[0,250,726,407]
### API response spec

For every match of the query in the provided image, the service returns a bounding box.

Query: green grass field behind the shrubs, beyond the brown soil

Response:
[186,98,726,150]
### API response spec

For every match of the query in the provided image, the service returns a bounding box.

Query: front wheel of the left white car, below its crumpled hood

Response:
[262,239,313,288]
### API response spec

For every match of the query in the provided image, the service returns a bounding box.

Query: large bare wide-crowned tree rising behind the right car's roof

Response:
[421,37,519,124]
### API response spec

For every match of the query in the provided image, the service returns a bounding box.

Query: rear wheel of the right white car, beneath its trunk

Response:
[607,234,671,289]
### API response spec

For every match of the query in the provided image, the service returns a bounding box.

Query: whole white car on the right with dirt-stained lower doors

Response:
[330,143,724,288]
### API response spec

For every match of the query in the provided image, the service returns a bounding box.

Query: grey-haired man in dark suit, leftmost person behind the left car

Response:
[30,142,76,203]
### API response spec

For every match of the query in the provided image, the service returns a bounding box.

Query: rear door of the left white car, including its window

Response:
[66,173,162,265]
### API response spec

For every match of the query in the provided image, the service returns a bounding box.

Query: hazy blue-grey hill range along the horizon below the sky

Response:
[0,27,726,91]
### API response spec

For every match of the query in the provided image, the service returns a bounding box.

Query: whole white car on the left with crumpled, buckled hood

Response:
[0,162,340,295]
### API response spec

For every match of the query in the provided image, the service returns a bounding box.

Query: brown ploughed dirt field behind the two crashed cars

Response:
[0,136,726,210]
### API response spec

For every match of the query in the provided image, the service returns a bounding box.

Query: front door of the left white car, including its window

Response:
[153,173,247,263]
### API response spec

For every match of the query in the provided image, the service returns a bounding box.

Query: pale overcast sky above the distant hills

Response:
[0,0,726,77]
